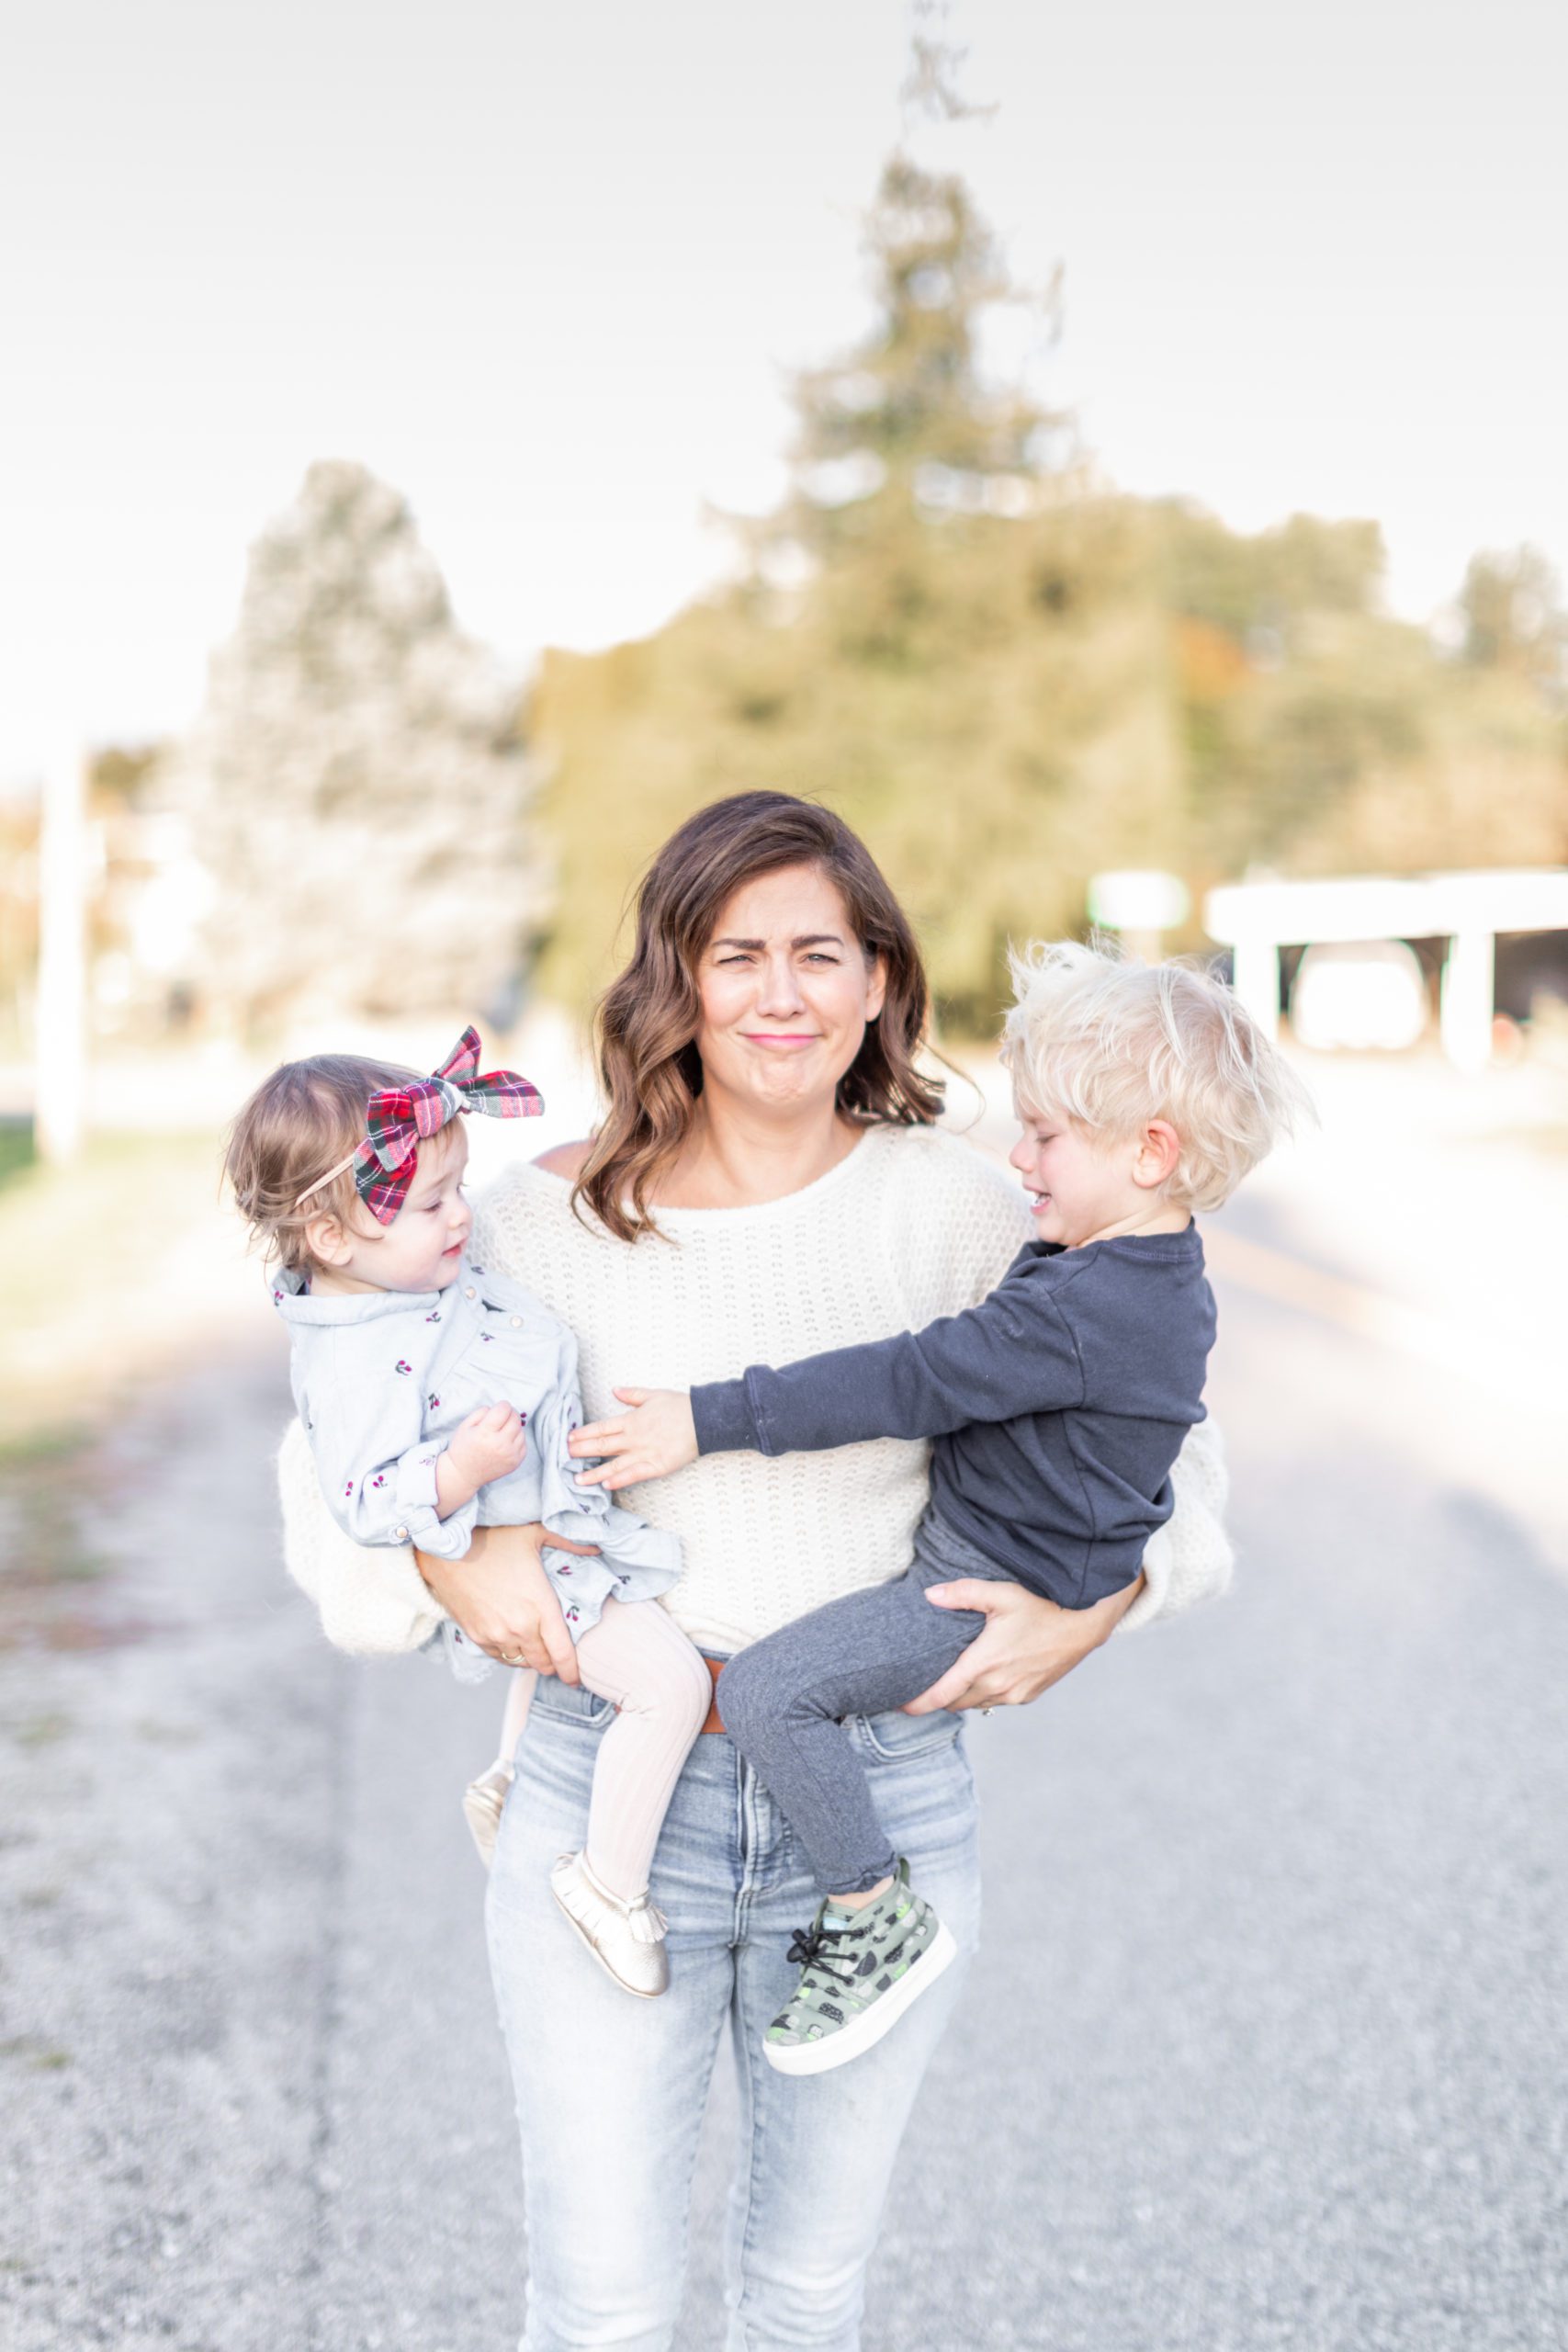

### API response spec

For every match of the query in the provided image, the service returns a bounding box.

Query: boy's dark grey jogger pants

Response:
[719,1520,1016,1895]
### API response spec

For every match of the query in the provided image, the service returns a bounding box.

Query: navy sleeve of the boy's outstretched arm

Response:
[691,1272,1084,1453]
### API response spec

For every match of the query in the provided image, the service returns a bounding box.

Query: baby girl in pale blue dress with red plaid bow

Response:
[226,1030,712,1996]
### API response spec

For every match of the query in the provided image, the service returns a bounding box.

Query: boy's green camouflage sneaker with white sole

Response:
[761,1860,959,2075]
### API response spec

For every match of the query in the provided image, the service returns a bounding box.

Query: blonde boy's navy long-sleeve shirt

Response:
[691,1226,1215,1609]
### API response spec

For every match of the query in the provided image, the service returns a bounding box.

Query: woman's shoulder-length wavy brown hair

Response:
[571,793,942,1242]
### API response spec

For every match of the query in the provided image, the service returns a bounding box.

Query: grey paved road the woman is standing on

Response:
[0,1250,1568,2352]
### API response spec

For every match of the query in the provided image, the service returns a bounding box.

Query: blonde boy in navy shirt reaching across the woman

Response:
[571,944,1304,2075]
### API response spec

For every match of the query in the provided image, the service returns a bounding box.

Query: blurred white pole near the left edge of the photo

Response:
[33,743,89,1167]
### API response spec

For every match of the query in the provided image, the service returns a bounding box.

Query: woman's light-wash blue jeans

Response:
[489,1679,980,2352]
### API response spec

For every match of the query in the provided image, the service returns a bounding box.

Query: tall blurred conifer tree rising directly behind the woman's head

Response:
[534,155,1180,1028]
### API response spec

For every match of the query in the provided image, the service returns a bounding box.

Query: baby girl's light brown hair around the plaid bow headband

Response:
[223,1054,416,1272]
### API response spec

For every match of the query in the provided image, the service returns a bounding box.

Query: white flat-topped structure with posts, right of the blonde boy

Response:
[1203,865,1568,1070]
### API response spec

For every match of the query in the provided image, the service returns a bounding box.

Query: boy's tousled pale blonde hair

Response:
[1001,938,1314,1209]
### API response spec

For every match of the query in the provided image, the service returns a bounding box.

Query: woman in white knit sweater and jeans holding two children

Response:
[282,793,1229,2352]
